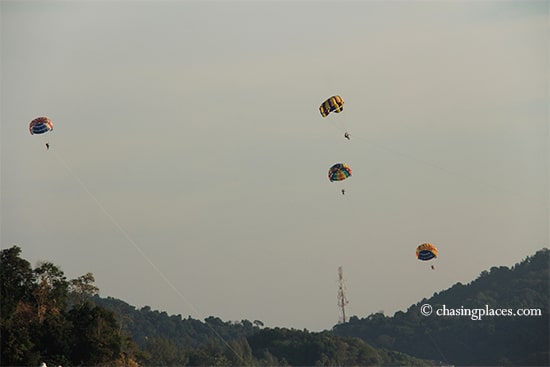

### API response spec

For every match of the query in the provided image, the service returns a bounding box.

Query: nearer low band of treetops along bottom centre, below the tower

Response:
[123,328,429,366]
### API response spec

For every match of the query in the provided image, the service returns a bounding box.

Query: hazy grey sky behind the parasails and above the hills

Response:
[0,0,550,330]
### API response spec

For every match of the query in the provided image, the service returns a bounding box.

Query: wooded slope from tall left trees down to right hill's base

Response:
[0,246,433,367]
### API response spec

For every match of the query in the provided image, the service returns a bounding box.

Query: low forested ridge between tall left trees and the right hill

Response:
[92,295,434,366]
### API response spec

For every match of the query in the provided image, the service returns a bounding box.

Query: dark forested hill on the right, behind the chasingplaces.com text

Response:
[333,249,550,366]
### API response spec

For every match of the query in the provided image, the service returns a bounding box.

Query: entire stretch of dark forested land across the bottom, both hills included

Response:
[0,246,550,367]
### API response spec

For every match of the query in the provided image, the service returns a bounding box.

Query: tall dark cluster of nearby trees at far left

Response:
[0,246,130,366]
